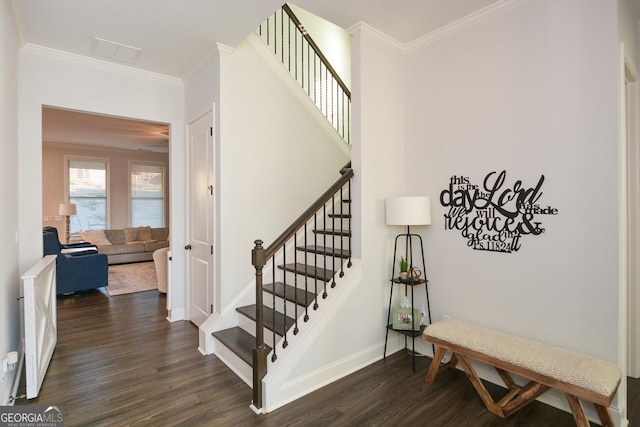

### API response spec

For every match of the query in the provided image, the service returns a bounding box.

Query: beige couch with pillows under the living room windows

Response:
[80,227,169,264]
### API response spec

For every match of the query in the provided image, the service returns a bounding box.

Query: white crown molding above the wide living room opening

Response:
[20,43,183,87]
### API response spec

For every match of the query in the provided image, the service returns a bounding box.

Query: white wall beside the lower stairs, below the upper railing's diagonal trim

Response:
[216,37,349,307]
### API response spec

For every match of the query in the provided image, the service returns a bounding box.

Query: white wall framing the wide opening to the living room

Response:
[18,45,185,320]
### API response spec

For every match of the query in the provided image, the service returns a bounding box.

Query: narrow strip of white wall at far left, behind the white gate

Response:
[0,1,20,390]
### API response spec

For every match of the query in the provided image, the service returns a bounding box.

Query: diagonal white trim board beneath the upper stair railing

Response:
[246,33,351,159]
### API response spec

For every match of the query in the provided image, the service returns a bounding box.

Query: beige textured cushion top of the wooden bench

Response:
[424,319,622,396]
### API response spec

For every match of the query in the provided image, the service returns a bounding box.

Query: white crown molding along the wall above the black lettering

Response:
[404,0,529,53]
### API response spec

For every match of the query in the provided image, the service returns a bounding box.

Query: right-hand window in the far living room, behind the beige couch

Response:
[130,163,165,227]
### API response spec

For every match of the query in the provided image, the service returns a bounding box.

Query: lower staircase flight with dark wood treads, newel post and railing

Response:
[213,165,353,412]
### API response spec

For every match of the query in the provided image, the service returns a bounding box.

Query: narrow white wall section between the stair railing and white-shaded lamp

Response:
[345,24,408,357]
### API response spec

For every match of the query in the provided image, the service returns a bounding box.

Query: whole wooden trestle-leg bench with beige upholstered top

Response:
[422,319,622,427]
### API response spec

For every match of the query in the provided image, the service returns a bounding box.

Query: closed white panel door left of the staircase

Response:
[185,113,214,326]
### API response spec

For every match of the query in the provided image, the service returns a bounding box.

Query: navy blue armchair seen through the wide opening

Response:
[42,227,109,295]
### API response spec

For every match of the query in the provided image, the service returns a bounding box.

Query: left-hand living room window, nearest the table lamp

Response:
[67,159,108,234]
